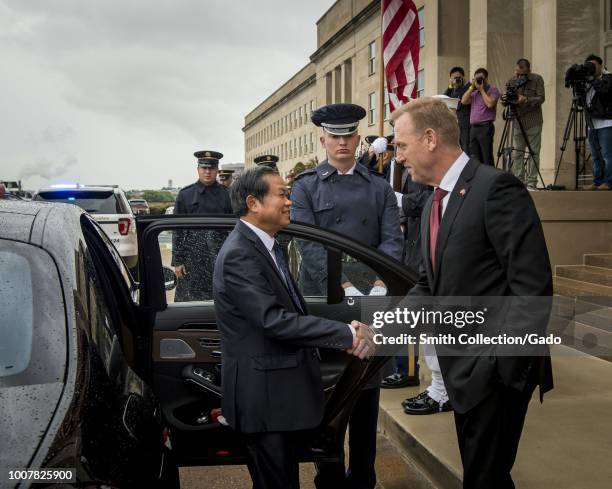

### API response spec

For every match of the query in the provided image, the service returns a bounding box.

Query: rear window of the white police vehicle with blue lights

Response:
[34,189,130,214]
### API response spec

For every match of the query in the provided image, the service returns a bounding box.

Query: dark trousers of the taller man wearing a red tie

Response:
[455,384,533,489]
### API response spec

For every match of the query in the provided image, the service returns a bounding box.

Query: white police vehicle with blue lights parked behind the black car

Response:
[34,183,138,268]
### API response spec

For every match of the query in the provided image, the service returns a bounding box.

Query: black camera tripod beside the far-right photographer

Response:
[552,87,601,188]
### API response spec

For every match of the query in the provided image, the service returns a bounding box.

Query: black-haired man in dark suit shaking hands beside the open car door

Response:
[213,165,374,489]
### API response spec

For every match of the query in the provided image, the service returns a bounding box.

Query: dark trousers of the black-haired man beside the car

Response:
[242,432,301,489]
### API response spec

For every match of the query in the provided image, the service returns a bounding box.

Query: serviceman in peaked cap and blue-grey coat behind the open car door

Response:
[291,104,403,489]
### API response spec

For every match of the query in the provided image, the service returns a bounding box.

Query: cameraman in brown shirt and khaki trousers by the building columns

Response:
[502,58,545,190]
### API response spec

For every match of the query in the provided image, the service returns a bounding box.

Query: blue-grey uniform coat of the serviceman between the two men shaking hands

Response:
[291,160,403,295]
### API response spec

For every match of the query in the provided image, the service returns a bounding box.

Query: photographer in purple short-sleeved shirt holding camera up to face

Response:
[461,68,499,166]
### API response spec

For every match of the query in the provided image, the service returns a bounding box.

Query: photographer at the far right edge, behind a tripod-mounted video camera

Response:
[585,54,612,190]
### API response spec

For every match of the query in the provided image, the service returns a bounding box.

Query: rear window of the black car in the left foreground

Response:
[0,240,66,389]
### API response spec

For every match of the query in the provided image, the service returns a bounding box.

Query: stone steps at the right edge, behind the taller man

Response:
[549,253,612,361]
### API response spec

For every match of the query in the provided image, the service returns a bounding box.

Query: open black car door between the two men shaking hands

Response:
[137,215,415,466]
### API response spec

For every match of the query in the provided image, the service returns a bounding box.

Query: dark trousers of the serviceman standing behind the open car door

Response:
[315,387,380,489]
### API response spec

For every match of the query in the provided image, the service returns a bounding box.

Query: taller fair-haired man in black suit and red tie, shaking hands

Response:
[393,98,552,489]
